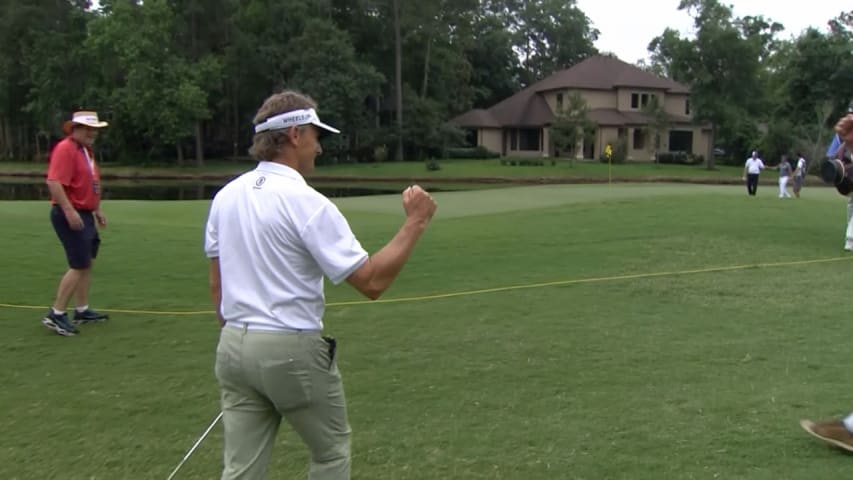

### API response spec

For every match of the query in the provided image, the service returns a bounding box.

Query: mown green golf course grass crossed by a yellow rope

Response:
[0,184,853,480]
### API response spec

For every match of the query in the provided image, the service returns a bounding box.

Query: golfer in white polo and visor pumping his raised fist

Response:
[205,91,436,480]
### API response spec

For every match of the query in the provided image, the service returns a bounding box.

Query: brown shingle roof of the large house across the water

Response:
[451,56,690,128]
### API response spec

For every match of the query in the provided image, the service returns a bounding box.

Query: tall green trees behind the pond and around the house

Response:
[0,0,853,164]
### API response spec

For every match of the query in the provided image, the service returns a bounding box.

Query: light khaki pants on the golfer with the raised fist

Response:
[216,325,351,480]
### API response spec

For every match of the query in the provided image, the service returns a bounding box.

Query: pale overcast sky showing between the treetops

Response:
[577,0,850,63]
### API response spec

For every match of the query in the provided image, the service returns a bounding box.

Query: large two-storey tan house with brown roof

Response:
[450,56,711,160]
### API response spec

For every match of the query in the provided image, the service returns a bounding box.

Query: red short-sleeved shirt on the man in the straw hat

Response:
[47,137,101,210]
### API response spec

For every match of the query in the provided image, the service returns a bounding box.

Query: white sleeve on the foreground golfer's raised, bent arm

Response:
[301,202,368,285]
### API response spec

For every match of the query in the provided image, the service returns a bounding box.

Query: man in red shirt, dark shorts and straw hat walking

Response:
[42,112,107,336]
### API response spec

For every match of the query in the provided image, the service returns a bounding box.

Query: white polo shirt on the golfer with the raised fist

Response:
[204,162,368,330]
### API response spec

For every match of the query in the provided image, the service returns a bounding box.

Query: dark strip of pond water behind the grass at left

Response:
[0,179,401,200]
